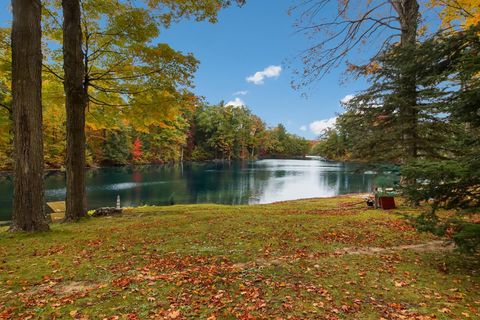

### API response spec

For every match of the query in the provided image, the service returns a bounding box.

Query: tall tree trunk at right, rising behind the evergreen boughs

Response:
[392,0,420,163]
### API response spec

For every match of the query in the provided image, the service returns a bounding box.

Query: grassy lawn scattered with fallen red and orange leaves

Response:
[0,196,480,320]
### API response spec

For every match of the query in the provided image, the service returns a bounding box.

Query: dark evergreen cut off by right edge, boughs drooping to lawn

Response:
[402,24,480,252]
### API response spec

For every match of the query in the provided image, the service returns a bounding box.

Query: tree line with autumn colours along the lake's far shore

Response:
[0,97,311,170]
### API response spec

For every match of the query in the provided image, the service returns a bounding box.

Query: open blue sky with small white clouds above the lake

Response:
[0,0,372,138]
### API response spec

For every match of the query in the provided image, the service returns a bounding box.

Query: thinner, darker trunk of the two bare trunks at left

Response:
[62,0,87,221]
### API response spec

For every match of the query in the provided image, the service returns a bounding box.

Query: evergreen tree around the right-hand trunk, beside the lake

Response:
[338,38,456,164]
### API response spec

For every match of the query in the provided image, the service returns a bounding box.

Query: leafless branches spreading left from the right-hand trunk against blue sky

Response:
[290,0,407,87]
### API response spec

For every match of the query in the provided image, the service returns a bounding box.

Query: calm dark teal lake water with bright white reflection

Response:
[0,159,397,221]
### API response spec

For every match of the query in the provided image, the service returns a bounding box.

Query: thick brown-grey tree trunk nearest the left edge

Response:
[11,0,49,231]
